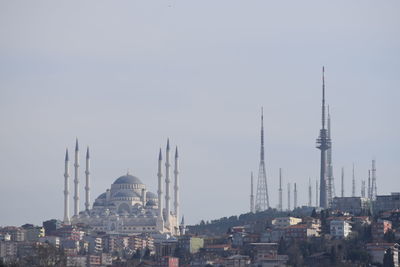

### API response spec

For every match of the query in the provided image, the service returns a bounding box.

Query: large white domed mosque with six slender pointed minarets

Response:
[63,140,185,236]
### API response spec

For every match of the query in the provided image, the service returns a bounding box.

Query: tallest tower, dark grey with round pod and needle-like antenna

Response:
[317,67,331,208]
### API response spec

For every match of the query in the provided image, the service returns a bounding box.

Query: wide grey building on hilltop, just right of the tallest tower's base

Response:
[332,197,370,215]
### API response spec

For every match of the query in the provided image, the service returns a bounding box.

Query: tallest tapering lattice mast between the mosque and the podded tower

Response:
[256,108,269,211]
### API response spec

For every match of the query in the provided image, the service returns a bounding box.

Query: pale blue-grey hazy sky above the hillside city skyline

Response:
[0,0,400,226]
